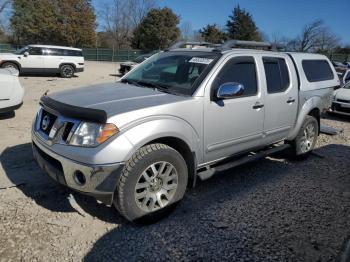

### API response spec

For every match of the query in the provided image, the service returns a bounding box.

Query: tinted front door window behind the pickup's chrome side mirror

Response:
[215,57,258,96]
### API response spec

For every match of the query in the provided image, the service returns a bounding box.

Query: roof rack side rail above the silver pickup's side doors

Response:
[216,39,285,51]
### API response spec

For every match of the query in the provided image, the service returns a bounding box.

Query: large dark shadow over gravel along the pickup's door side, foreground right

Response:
[84,145,350,261]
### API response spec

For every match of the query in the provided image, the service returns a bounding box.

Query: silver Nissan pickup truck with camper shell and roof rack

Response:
[32,41,340,221]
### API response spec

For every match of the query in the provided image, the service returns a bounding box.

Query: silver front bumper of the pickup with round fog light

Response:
[32,133,124,205]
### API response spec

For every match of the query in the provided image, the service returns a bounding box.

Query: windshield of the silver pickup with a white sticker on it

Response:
[122,51,220,95]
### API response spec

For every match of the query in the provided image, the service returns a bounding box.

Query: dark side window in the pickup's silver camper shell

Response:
[302,60,334,82]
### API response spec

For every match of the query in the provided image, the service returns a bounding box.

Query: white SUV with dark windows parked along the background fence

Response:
[0,45,84,78]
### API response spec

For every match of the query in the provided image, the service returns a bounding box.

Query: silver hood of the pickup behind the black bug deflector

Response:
[48,83,189,117]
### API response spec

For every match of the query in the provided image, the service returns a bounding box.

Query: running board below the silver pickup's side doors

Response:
[197,144,290,181]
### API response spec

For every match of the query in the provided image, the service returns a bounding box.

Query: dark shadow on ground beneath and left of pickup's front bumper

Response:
[0,143,122,223]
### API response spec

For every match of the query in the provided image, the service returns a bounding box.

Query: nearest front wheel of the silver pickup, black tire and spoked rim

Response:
[114,144,188,223]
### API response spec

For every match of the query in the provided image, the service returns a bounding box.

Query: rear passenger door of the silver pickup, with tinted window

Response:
[261,56,298,143]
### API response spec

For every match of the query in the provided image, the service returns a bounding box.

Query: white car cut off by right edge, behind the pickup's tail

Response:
[329,82,350,115]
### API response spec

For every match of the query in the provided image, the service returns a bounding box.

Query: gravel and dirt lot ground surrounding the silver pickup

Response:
[0,62,350,261]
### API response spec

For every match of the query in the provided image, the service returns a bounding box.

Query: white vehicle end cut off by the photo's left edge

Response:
[0,68,24,113]
